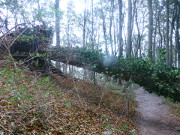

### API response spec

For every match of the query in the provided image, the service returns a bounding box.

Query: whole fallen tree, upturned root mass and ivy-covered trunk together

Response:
[0,27,180,101]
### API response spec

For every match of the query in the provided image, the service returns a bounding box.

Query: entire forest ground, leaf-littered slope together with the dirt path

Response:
[0,53,180,135]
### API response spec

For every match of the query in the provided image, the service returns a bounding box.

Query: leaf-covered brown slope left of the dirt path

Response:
[0,55,137,135]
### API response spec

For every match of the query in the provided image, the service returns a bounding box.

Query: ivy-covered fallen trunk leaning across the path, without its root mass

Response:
[50,47,180,101]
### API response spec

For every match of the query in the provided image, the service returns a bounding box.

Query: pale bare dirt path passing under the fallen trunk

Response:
[135,88,180,135]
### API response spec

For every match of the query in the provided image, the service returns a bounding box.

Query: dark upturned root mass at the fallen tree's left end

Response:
[0,25,53,55]
